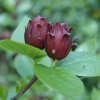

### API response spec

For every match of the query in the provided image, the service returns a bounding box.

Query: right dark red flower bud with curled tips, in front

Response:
[45,22,76,60]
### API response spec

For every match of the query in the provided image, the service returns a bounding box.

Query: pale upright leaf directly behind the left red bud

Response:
[11,17,30,43]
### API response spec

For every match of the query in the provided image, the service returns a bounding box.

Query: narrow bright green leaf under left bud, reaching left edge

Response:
[0,39,46,59]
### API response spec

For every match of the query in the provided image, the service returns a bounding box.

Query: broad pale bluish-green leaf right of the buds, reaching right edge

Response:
[56,52,100,76]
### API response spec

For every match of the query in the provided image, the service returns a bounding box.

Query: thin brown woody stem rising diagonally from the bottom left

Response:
[11,75,38,100]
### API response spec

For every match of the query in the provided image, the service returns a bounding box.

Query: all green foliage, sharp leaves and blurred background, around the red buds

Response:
[0,0,100,100]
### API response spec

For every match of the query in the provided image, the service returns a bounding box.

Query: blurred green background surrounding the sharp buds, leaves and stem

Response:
[0,0,100,100]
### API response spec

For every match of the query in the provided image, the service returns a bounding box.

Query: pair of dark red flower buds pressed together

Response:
[24,16,77,60]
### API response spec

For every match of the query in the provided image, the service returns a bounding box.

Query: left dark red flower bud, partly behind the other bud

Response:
[24,16,48,49]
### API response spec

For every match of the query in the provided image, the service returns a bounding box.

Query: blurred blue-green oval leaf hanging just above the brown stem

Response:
[14,55,34,78]
